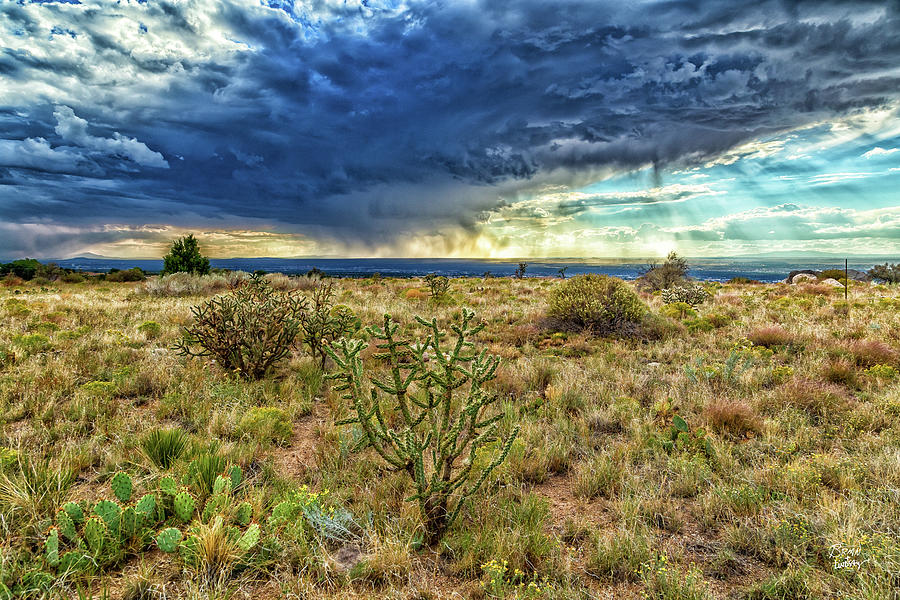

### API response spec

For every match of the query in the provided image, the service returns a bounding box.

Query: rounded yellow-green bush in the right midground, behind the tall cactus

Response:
[547,274,648,335]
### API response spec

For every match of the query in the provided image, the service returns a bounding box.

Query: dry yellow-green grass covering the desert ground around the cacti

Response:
[0,275,900,600]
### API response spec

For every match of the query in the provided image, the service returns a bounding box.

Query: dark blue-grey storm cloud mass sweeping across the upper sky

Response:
[0,0,900,255]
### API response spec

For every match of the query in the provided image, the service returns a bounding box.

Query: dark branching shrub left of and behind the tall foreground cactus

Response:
[175,276,308,379]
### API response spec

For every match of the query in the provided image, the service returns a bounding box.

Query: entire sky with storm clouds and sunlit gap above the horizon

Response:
[0,0,900,258]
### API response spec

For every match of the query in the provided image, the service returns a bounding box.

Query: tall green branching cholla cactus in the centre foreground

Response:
[327,309,519,544]
